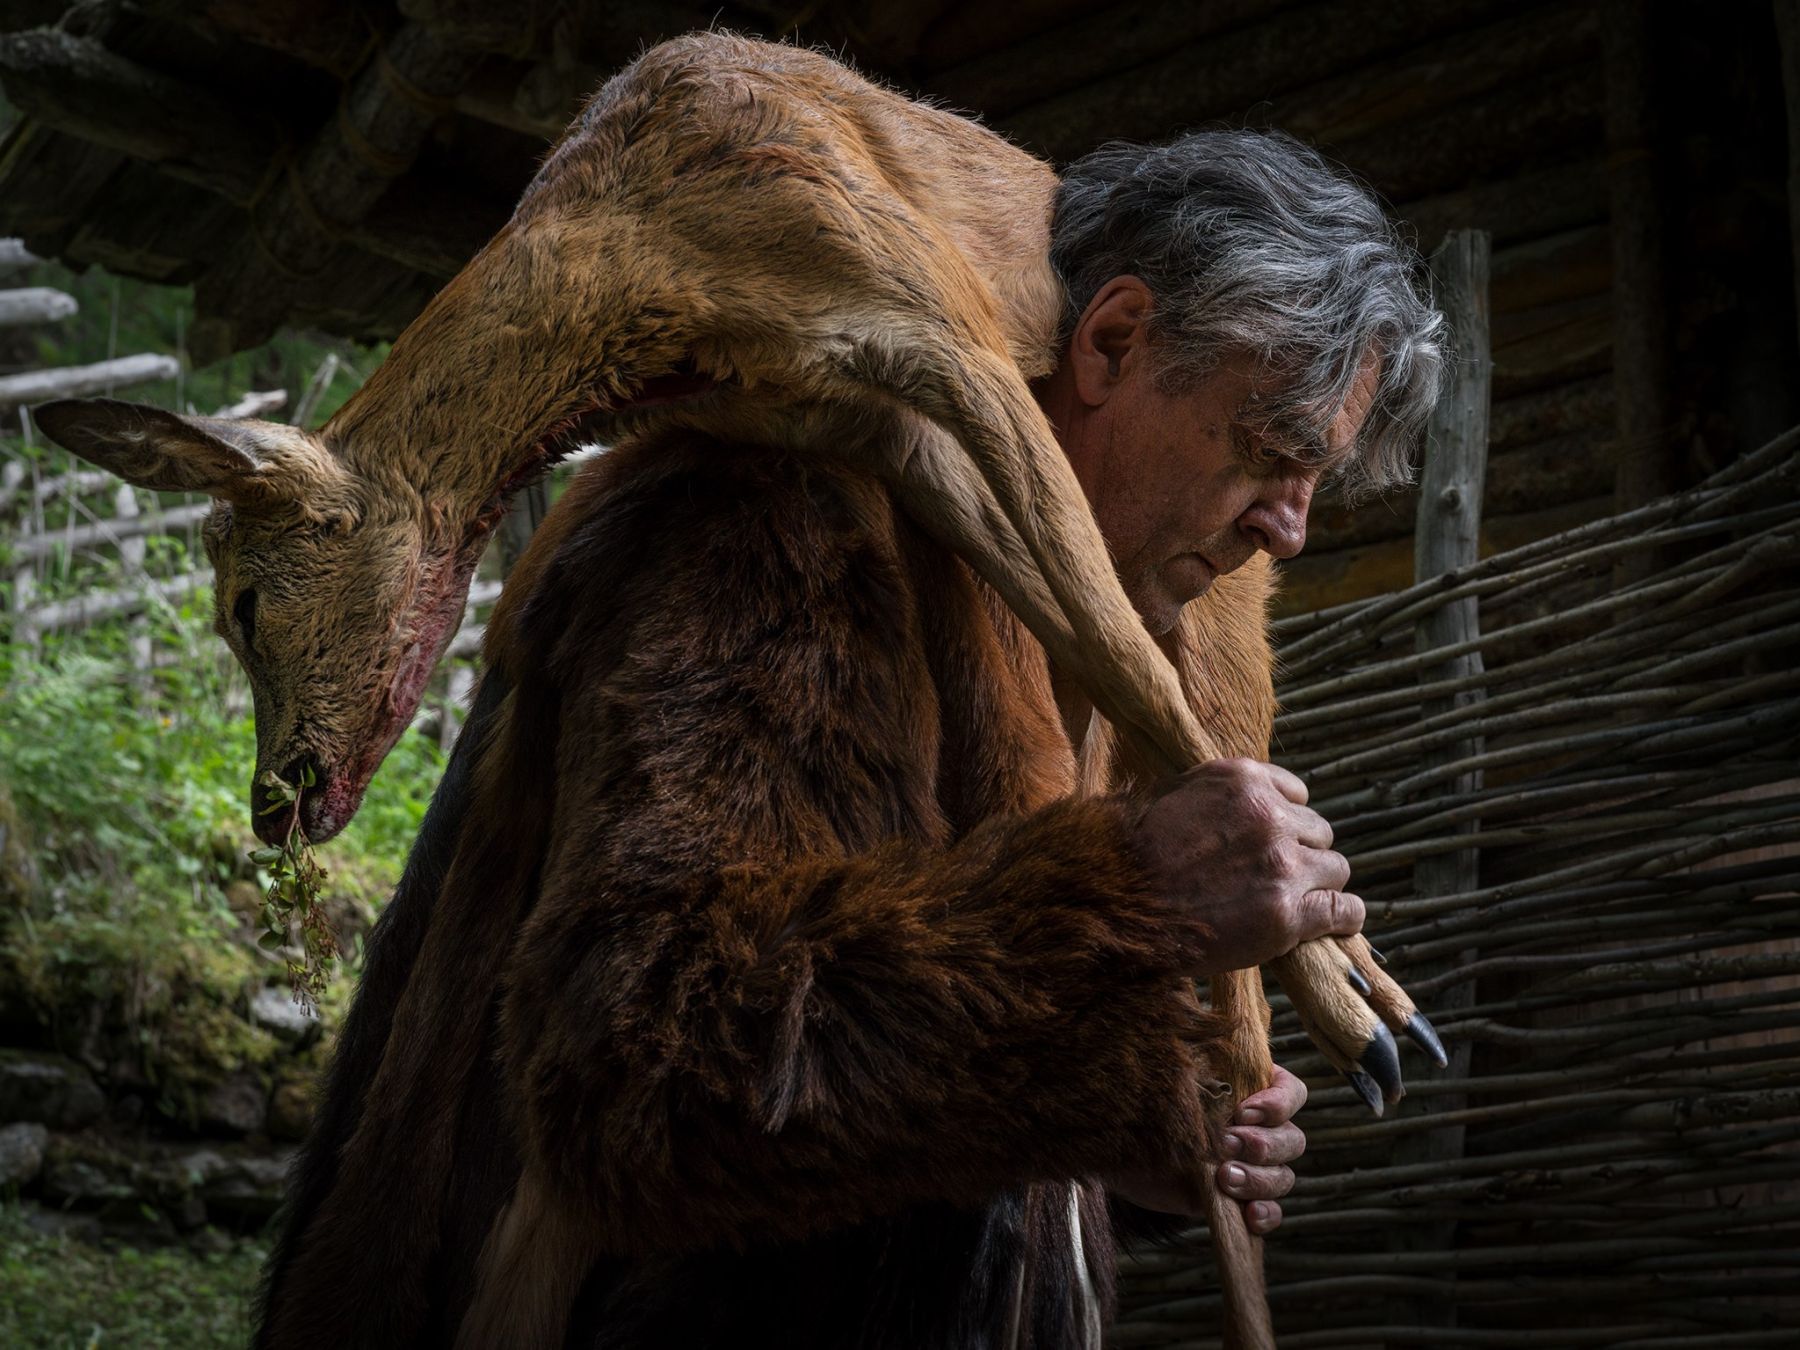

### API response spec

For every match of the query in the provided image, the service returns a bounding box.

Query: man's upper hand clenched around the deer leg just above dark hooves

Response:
[1138,760,1363,976]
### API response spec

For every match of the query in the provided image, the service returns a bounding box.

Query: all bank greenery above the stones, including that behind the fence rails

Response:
[0,265,432,1094]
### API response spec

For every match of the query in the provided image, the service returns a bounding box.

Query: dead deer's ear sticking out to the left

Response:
[31,398,283,504]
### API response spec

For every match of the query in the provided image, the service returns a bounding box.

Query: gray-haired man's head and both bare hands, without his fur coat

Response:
[1035,131,1444,1233]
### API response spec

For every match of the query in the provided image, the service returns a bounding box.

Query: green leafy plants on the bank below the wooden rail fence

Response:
[0,592,443,1094]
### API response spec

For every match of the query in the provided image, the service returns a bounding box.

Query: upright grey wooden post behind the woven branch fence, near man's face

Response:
[1393,230,1492,1327]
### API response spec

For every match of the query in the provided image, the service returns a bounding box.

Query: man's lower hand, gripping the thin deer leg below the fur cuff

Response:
[1107,1064,1307,1233]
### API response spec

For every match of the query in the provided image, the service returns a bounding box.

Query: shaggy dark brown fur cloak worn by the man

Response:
[257,434,1271,1350]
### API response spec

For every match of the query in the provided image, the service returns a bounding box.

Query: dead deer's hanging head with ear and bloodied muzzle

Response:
[34,400,493,842]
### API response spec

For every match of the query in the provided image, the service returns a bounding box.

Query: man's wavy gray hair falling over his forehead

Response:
[1049,131,1447,491]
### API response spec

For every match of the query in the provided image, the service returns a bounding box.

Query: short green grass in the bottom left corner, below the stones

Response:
[0,1204,265,1350]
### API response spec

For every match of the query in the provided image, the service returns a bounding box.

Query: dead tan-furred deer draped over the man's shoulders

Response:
[40,34,1432,1345]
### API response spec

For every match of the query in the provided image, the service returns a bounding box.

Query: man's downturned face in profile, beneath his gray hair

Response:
[1044,279,1377,635]
